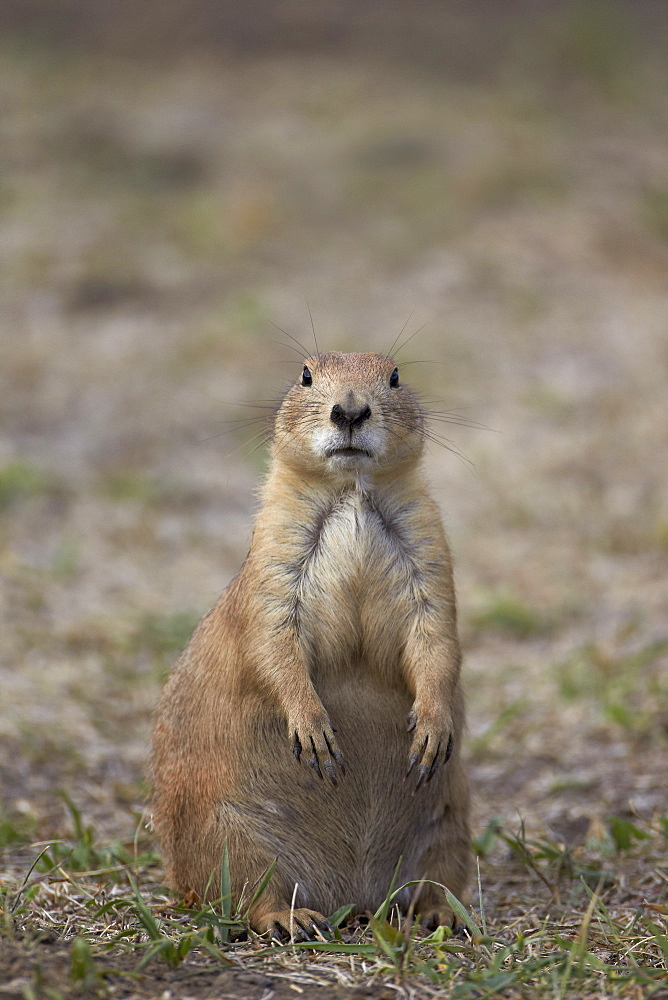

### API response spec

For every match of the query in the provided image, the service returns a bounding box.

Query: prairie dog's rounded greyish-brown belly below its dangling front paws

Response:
[226,665,447,913]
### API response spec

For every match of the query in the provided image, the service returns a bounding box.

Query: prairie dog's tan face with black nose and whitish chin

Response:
[274,352,424,480]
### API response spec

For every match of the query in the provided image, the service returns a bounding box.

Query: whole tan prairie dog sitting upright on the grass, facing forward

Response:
[151,352,469,938]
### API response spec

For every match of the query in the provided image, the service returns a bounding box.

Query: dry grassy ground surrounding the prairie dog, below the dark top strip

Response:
[0,3,668,1000]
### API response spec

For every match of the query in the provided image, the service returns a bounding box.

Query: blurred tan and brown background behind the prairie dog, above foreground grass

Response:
[0,0,668,841]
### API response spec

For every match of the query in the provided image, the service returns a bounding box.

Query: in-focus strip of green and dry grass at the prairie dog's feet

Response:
[3,798,668,998]
